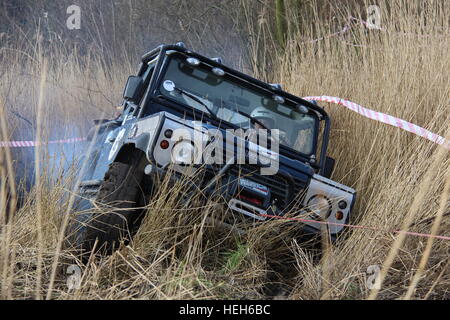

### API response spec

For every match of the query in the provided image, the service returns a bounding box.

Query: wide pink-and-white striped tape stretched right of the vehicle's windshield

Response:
[303,96,450,149]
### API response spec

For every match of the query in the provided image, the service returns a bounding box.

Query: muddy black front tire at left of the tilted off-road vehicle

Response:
[77,153,145,261]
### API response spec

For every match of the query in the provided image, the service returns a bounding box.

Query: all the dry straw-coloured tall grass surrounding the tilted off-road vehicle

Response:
[0,0,450,299]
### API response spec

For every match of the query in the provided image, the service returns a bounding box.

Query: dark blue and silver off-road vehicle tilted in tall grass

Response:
[67,43,356,253]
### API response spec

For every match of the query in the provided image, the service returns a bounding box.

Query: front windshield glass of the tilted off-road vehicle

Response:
[159,54,318,155]
